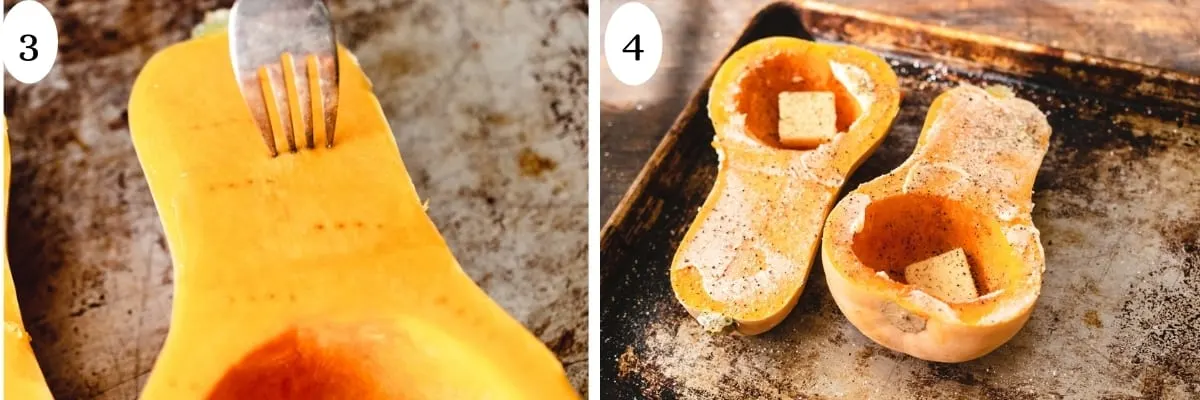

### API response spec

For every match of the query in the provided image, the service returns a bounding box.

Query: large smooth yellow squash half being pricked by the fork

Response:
[130,32,578,400]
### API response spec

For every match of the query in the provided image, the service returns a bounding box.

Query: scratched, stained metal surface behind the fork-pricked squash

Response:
[5,0,588,399]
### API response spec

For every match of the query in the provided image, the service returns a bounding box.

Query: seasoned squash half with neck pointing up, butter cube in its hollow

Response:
[821,85,1050,363]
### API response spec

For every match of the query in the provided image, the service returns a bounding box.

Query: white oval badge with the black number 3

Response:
[0,0,59,84]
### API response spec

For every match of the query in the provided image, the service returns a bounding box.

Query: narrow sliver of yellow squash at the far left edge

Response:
[0,117,54,400]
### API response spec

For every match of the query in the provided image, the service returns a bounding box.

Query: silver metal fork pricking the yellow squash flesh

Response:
[229,0,338,157]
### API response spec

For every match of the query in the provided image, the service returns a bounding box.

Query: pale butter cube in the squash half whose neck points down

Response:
[779,91,838,149]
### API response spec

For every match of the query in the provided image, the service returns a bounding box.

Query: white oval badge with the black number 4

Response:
[604,1,662,86]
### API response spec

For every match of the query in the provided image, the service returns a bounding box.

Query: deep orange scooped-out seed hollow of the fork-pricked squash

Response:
[208,329,382,400]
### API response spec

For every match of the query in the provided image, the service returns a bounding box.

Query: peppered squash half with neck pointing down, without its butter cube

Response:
[671,37,900,335]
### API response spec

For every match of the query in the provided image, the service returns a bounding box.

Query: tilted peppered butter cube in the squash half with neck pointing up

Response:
[904,249,979,303]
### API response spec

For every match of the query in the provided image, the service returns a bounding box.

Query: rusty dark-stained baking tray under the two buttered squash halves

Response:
[600,4,1200,399]
